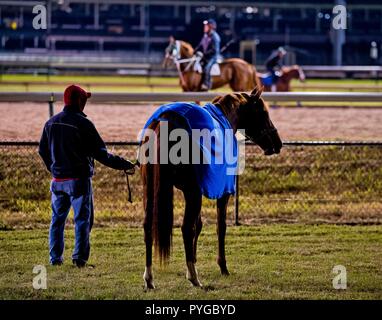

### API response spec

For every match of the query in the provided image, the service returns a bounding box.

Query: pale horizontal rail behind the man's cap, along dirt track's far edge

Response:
[0,92,382,115]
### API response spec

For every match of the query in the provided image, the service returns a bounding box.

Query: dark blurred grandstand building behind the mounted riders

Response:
[0,0,382,65]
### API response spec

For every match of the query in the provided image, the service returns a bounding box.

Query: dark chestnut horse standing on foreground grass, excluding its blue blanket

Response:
[140,89,282,289]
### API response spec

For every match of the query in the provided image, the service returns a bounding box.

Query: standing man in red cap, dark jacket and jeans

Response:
[39,85,134,267]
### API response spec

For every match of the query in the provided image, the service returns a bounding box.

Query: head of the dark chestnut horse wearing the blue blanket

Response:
[212,88,282,155]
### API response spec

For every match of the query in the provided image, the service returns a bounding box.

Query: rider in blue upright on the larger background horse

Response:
[195,19,220,91]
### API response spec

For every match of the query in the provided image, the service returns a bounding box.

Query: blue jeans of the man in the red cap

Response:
[49,178,94,264]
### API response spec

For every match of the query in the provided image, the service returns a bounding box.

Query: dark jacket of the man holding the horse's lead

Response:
[39,106,133,178]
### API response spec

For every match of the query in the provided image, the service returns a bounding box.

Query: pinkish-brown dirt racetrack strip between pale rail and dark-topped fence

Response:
[0,103,382,141]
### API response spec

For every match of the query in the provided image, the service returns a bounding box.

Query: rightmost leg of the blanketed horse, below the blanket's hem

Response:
[216,195,229,276]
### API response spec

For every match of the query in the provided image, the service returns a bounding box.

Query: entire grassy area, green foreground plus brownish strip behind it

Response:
[0,147,382,299]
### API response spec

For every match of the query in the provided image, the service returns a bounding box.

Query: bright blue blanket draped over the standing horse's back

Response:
[141,102,238,199]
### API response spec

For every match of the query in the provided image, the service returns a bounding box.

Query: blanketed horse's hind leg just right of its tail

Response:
[182,189,202,287]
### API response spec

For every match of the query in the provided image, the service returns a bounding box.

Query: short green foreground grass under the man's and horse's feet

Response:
[0,224,382,299]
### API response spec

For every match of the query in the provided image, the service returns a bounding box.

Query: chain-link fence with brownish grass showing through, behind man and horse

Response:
[0,141,382,225]
